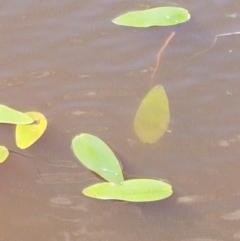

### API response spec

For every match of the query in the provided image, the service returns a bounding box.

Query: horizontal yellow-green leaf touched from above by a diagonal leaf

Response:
[83,179,173,202]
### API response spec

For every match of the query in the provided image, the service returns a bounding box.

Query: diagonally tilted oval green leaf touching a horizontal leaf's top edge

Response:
[72,133,123,184]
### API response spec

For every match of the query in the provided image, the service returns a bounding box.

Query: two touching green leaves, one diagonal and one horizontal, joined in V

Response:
[72,134,172,202]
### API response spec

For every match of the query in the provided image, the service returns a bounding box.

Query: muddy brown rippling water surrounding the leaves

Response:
[0,0,240,241]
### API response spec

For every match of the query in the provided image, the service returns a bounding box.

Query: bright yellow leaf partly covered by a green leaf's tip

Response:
[16,112,47,149]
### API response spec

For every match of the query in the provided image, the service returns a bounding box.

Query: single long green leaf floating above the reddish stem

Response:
[112,6,190,28]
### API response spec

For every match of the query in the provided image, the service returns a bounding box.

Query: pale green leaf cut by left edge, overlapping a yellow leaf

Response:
[0,105,33,125]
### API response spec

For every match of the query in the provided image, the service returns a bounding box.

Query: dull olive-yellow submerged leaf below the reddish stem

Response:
[134,85,170,143]
